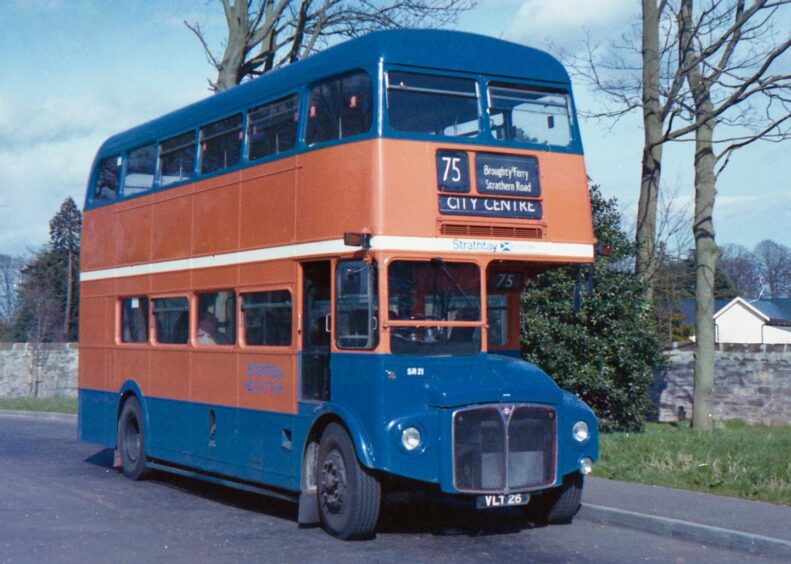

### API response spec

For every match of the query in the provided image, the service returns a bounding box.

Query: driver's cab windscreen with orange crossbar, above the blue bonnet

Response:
[388,259,481,355]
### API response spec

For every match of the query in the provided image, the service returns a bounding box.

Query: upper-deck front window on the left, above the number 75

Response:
[387,71,479,137]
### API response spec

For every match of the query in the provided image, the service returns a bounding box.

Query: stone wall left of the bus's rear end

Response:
[0,343,77,398]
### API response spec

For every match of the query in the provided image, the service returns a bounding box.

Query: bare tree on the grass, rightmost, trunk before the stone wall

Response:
[668,0,791,430]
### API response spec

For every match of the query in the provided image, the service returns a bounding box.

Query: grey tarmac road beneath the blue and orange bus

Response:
[0,413,784,564]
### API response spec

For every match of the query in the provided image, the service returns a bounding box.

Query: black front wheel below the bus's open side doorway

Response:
[317,423,382,540]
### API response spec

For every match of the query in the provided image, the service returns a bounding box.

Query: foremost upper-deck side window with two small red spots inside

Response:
[306,72,372,145]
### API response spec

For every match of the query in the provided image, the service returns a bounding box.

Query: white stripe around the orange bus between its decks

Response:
[80,235,593,282]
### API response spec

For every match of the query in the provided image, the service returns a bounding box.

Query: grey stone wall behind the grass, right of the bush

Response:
[651,344,791,425]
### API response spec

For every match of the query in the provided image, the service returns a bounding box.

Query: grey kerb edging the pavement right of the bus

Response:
[577,503,791,561]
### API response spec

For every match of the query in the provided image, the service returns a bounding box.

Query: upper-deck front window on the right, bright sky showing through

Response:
[489,82,571,147]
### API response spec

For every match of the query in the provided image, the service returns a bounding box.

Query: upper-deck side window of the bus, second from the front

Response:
[247,94,299,161]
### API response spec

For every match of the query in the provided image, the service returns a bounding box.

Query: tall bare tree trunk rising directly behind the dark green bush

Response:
[635,0,662,299]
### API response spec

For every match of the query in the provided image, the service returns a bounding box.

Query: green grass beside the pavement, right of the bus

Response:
[593,422,791,505]
